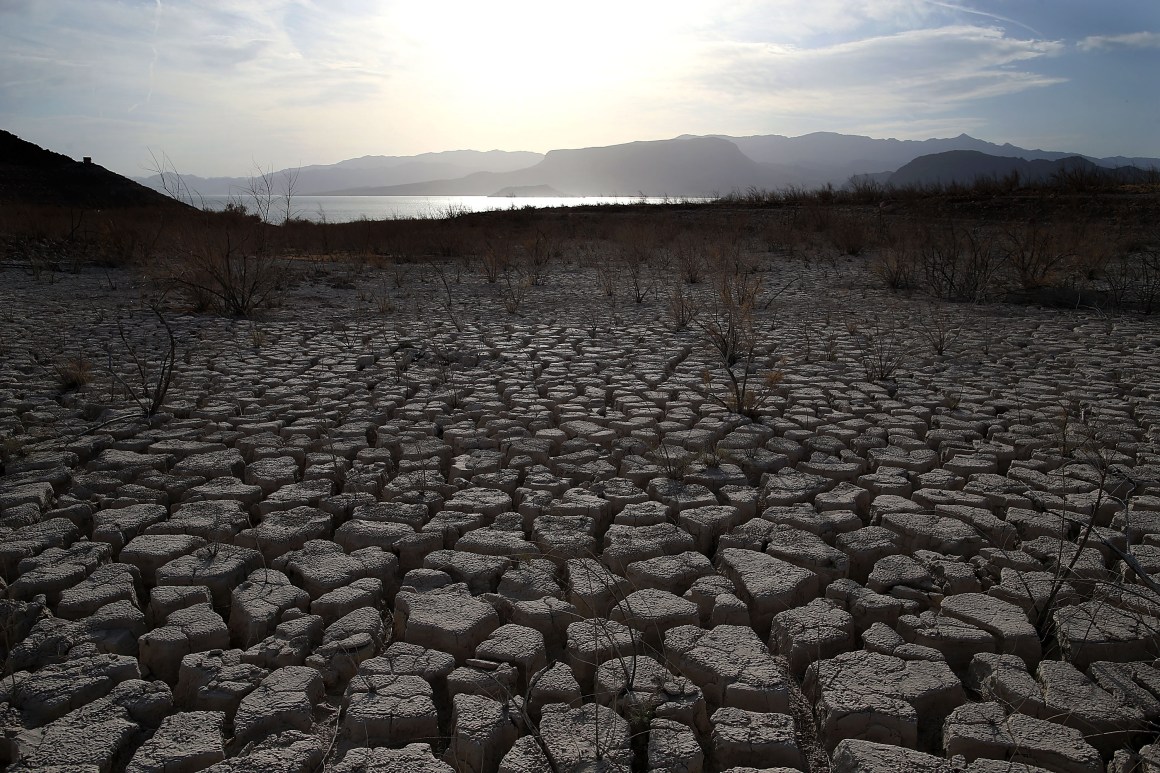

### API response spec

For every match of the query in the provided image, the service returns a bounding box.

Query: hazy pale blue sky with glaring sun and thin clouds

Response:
[0,0,1160,175]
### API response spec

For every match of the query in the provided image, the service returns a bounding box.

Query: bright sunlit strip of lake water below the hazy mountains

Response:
[202,196,709,223]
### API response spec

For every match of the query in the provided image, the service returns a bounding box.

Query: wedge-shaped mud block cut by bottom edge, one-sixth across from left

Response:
[125,711,225,773]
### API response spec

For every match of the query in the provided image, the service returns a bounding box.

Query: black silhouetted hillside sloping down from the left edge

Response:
[0,130,183,209]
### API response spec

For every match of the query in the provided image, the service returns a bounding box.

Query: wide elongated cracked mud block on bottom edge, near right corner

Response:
[943,703,1103,773]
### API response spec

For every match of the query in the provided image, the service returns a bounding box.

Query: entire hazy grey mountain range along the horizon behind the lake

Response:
[131,132,1160,196]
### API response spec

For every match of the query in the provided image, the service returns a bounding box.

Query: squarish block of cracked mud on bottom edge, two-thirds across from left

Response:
[711,707,805,771]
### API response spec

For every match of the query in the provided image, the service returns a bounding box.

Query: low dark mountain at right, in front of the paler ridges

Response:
[887,151,1146,187]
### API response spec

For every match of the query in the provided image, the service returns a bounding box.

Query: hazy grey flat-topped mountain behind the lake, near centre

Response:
[322,137,781,196]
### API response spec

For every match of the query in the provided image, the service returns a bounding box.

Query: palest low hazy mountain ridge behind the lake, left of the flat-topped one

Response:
[138,151,544,196]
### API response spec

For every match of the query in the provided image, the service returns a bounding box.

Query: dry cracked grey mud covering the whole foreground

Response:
[0,254,1160,773]
